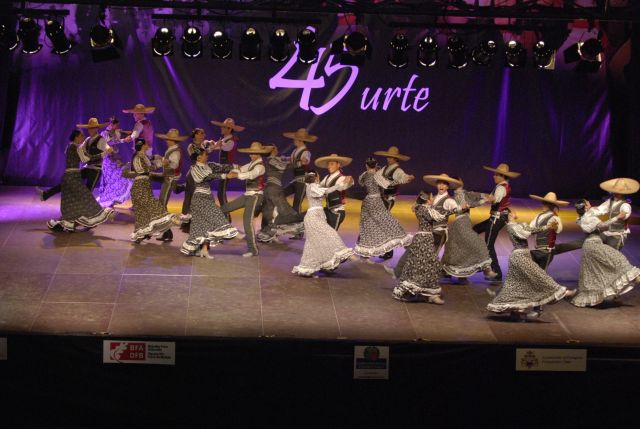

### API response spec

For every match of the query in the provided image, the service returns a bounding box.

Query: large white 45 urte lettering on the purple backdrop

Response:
[269,44,429,115]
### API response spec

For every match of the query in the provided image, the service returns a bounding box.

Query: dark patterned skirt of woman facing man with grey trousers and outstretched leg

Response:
[180,192,238,256]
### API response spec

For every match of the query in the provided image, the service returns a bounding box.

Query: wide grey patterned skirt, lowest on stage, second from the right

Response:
[487,249,567,313]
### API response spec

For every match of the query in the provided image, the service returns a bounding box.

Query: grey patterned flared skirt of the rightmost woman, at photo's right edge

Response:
[571,235,640,307]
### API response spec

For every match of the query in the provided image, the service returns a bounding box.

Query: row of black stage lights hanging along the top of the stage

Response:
[0,17,603,72]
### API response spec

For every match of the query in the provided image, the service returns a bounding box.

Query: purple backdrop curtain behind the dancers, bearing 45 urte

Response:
[4,7,610,198]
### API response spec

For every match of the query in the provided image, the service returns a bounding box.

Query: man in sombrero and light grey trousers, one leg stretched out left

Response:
[222,142,272,258]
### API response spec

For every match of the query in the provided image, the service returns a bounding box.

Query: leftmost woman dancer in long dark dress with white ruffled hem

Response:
[47,130,114,232]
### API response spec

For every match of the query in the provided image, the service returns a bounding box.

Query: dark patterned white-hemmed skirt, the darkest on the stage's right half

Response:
[393,231,442,301]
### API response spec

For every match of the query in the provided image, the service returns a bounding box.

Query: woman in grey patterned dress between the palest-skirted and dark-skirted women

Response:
[354,158,413,258]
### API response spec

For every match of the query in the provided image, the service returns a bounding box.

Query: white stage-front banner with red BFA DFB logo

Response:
[102,340,176,365]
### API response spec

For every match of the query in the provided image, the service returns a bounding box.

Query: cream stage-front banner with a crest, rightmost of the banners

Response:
[516,349,587,372]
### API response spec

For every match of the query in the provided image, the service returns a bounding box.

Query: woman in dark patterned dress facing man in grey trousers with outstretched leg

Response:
[180,148,238,259]
